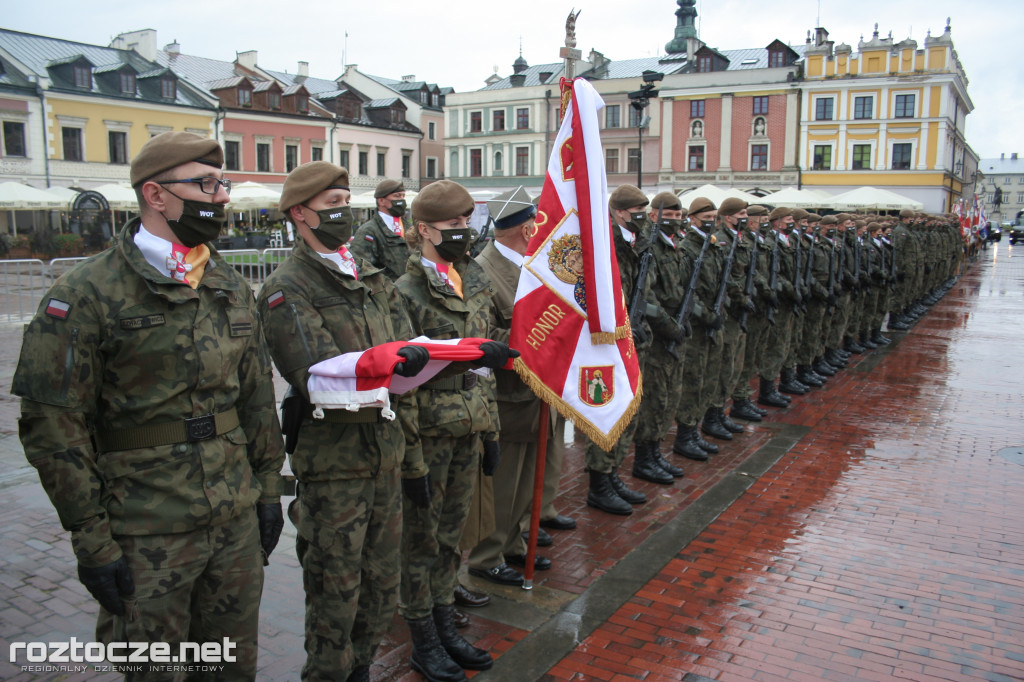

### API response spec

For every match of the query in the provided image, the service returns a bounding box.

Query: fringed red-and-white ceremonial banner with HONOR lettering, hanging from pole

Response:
[509,79,642,450]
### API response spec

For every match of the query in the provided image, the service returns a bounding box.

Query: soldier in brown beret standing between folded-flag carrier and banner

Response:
[395,180,516,680]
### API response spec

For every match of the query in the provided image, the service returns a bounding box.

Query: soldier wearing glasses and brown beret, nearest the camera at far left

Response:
[12,132,284,680]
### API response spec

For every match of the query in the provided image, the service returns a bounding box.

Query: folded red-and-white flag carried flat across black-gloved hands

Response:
[306,336,490,419]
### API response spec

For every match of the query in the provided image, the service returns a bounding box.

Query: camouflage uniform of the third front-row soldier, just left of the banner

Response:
[395,251,500,621]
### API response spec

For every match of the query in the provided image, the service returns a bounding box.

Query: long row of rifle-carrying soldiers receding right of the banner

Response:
[587,185,964,514]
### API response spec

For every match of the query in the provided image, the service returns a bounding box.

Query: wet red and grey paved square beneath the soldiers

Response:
[0,245,1024,682]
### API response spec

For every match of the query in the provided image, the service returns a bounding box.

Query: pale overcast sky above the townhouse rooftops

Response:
[0,0,1024,158]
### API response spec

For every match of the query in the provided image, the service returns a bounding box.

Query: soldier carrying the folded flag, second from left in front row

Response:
[258,161,429,682]
